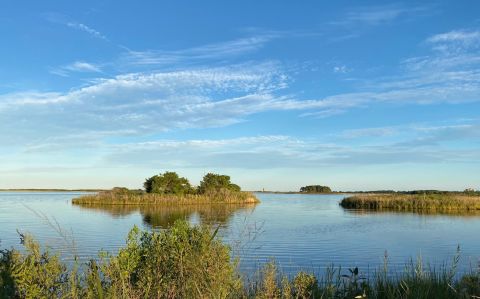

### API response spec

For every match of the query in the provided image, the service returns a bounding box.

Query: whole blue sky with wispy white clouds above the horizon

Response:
[0,0,480,191]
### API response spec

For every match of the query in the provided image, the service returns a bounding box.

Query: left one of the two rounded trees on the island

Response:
[143,171,192,195]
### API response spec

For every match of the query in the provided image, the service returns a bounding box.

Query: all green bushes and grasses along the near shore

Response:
[0,221,480,299]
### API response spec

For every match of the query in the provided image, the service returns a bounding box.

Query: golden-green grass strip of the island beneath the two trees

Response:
[72,188,259,206]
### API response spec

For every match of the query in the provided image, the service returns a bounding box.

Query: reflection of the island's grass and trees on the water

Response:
[76,203,256,228]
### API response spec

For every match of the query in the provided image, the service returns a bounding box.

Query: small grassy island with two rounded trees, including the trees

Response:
[72,171,259,205]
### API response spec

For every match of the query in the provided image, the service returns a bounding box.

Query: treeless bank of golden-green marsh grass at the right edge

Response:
[340,193,480,213]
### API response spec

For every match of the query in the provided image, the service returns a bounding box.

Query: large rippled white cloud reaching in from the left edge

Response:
[0,63,300,142]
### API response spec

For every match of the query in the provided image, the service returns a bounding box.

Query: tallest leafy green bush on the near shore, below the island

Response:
[95,221,242,298]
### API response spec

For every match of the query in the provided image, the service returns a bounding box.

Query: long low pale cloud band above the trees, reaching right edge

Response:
[100,124,480,169]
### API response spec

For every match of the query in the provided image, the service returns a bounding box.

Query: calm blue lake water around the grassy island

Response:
[0,192,480,272]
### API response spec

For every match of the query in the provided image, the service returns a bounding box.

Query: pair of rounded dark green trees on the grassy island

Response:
[143,171,241,195]
